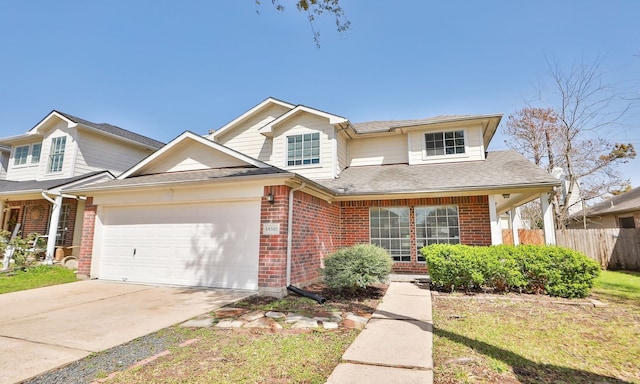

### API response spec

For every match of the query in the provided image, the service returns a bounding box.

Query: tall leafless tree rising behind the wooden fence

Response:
[506,60,638,228]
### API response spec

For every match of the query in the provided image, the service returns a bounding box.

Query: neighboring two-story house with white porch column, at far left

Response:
[0,111,163,258]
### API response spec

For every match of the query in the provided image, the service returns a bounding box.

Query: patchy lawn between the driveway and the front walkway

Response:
[108,328,357,384]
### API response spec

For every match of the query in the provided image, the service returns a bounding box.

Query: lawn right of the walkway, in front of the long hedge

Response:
[433,271,640,384]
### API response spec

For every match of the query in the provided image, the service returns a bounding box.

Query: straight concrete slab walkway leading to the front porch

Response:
[327,279,433,384]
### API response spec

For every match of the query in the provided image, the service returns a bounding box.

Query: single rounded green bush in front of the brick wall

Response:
[322,244,393,291]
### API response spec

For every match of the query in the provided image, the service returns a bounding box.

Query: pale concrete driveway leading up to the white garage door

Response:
[0,280,254,384]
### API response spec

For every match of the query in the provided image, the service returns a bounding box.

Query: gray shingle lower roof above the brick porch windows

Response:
[316,151,560,195]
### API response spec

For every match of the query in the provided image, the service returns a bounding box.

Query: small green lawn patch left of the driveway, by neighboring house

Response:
[0,265,77,294]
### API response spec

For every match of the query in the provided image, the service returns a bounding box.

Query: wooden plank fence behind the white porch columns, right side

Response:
[502,228,640,271]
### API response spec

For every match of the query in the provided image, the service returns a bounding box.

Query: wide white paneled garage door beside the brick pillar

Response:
[99,201,260,289]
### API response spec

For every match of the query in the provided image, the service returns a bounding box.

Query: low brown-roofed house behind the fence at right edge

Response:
[568,188,640,228]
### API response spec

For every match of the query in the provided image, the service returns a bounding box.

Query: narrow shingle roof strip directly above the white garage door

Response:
[67,167,290,191]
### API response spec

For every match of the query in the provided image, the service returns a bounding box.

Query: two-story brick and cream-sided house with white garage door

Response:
[66,98,559,296]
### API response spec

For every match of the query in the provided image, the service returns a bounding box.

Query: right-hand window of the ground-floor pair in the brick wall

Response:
[415,205,460,262]
